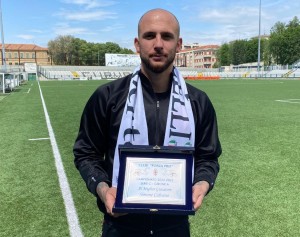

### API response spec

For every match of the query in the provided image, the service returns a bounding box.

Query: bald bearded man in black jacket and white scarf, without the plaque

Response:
[74,9,221,237]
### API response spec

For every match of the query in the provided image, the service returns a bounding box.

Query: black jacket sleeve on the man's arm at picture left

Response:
[73,88,110,196]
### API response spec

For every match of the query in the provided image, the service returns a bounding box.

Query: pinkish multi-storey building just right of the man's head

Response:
[174,45,220,68]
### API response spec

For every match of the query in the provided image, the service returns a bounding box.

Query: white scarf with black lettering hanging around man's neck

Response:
[112,67,195,187]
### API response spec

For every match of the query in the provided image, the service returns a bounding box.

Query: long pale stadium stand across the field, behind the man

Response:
[38,64,300,80]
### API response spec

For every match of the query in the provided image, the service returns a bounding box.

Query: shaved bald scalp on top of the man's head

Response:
[138,8,180,37]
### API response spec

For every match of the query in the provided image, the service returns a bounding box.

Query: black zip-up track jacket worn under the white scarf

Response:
[73,73,222,230]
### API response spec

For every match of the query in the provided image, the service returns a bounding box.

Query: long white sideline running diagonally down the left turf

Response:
[38,81,83,237]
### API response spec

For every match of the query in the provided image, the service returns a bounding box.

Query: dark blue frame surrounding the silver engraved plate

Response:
[113,145,195,215]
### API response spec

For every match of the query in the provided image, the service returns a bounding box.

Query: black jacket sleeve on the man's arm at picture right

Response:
[194,94,222,192]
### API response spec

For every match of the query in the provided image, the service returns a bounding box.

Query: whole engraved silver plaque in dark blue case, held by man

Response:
[113,145,195,215]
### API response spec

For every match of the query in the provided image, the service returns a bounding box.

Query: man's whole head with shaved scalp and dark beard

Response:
[134,11,182,73]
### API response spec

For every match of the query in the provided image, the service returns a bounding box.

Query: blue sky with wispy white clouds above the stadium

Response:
[0,0,300,50]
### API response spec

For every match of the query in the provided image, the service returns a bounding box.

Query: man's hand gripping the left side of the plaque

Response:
[97,182,126,217]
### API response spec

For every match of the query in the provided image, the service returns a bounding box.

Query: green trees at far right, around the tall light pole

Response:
[217,17,300,66]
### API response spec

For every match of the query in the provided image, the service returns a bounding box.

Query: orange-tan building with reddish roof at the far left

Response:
[0,44,51,65]
